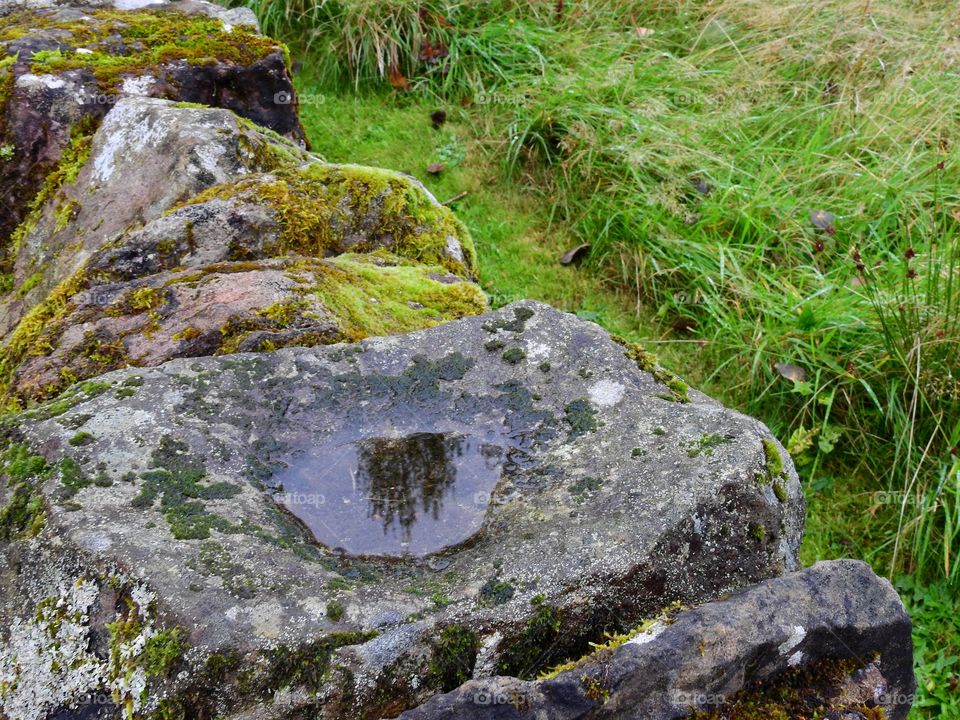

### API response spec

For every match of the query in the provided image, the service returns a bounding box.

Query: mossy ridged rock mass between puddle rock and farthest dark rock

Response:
[0,97,487,400]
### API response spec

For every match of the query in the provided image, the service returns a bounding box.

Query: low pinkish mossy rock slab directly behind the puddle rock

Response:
[5,251,487,403]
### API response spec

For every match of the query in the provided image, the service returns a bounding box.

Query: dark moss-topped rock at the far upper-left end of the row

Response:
[0,0,304,245]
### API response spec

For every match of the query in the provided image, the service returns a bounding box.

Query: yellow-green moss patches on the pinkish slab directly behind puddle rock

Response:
[0,251,480,410]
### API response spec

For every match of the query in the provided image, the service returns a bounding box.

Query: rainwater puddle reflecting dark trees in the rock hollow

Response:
[273,432,505,557]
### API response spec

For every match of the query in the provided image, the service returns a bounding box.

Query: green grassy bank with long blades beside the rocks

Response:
[231,0,960,718]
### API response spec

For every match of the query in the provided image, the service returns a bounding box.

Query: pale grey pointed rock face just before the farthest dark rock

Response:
[0,98,312,336]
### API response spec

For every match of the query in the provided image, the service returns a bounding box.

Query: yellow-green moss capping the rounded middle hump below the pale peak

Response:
[178,163,476,276]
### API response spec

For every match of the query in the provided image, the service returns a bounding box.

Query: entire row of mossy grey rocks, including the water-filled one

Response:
[0,0,913,720]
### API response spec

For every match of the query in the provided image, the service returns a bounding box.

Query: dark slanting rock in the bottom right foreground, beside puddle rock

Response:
[401,560,915,720]
